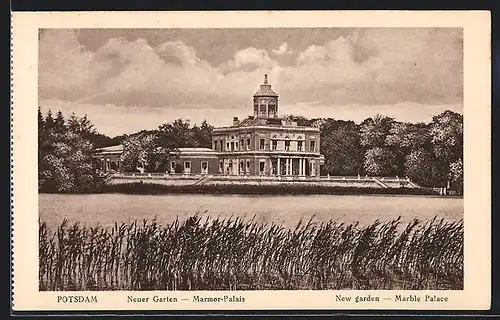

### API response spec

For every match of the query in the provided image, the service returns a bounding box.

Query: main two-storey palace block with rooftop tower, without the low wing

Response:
[212,75,324,176]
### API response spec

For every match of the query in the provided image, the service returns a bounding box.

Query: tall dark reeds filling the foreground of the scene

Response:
[39,215,463,291]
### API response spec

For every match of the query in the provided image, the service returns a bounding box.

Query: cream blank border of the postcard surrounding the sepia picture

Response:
[12,11,491,311]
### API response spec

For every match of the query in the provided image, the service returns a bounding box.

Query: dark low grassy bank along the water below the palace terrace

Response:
[94,182,442,195]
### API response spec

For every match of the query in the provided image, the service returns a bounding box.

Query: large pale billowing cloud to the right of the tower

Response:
[281,28,463,104]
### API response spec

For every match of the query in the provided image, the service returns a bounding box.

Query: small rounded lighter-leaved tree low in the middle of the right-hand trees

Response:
[364,147,398,176]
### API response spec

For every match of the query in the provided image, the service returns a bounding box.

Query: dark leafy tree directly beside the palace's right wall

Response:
[320,119,363,175]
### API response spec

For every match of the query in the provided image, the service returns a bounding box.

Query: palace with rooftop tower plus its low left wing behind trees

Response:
[95,75,324,177]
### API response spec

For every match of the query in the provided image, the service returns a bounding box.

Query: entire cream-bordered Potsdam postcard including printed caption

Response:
[11,11,491,311]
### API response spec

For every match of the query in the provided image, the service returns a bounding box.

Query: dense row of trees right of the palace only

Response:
[310,110,463,192]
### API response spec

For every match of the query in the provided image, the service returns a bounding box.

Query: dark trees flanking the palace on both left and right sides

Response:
[38,109,463,192]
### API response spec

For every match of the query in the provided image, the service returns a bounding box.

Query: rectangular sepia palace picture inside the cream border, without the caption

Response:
[38,28,464,291]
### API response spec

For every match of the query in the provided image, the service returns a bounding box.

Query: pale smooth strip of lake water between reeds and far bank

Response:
[39,194,464,229]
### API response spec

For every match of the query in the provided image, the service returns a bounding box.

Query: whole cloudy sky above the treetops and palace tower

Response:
[38,28,463,136]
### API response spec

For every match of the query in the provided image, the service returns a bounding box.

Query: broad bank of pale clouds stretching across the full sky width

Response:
[39,28,463,116]
